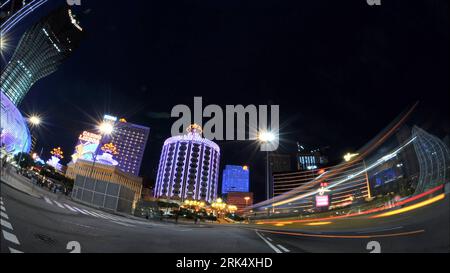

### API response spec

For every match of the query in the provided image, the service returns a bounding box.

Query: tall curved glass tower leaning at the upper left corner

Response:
[1,7,83,105]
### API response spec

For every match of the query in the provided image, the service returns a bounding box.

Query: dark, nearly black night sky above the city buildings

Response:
[6,0,449,202]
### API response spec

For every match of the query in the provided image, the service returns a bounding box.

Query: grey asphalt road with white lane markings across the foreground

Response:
[0,174,450,253]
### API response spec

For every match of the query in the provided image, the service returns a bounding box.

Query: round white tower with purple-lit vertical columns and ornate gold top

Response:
[155,124,220,203]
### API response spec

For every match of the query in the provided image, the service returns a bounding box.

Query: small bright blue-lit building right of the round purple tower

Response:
[222,165,250,194]
